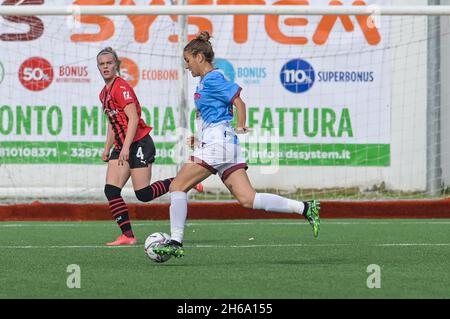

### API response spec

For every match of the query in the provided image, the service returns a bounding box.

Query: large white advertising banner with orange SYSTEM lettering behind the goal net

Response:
[0,0,391,166]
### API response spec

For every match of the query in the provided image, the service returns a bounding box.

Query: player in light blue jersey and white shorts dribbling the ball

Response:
[153,31,320,257]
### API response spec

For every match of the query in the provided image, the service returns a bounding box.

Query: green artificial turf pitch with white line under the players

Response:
[0,219,450,299]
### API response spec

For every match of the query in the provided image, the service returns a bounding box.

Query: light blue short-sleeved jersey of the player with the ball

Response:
[194,69,241,126]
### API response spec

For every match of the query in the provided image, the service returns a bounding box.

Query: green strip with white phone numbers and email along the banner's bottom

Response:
[0,142,390,166]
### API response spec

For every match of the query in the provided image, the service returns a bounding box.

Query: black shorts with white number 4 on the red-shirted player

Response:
[109,135,156,168]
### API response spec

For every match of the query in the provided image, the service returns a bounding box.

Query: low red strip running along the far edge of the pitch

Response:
[0,199,450,221]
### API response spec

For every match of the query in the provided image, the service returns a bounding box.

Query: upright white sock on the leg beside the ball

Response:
[170,192,187,243]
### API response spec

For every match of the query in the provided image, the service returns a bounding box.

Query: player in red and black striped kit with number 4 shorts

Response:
[97,47,203,246]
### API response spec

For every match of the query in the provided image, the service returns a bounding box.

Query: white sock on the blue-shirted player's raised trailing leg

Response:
[253,193,305,214]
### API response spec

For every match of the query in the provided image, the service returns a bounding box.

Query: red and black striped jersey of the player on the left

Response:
[100,76,152,149]
